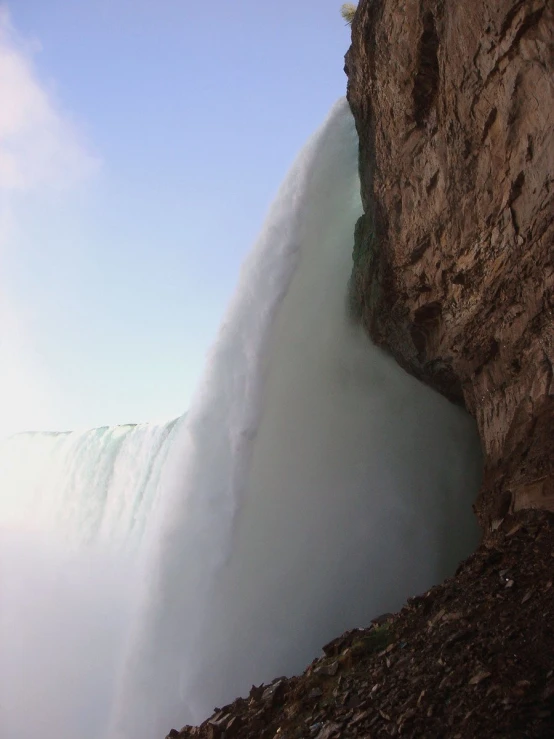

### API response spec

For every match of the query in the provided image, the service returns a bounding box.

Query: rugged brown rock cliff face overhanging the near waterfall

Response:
[346,0,554,530]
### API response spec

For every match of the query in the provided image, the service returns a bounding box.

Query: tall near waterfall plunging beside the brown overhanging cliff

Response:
[108,101,480,739]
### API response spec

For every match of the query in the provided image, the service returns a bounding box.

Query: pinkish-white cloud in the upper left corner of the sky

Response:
[0,7,99,193]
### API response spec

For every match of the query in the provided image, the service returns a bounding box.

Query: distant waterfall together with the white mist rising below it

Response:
[0,421,179,739]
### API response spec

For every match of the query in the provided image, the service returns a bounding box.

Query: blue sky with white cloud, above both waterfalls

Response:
[0,0,349,436]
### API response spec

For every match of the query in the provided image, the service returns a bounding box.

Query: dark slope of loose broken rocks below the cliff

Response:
[164,511,554,739]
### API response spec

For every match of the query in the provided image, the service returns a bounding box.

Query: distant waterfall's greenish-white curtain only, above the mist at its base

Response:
[0,419,179,543]
